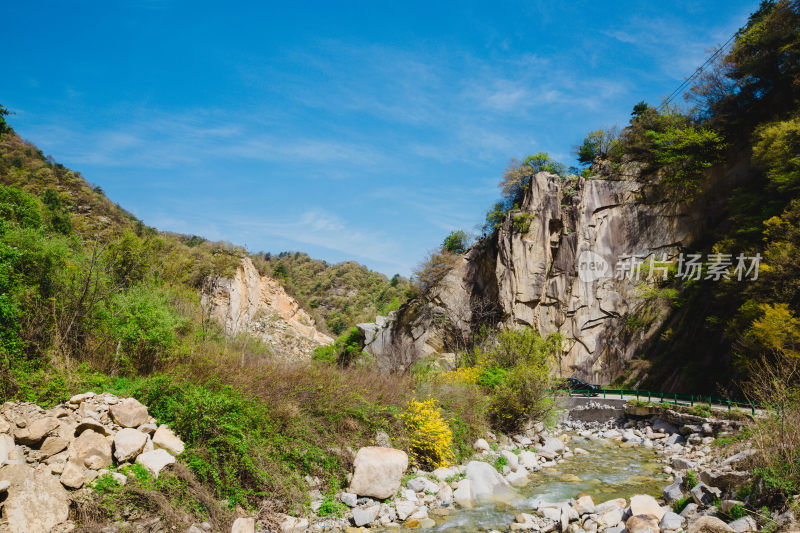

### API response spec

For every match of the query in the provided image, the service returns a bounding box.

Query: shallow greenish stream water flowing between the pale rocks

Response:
[390,436,667,532]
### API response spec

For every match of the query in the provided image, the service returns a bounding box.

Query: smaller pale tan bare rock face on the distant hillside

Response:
[202,257,333,358]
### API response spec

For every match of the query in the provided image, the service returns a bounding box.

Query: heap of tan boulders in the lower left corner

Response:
[0,392,184,532]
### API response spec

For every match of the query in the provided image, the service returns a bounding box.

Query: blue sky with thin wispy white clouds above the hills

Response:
[0,0,758,275]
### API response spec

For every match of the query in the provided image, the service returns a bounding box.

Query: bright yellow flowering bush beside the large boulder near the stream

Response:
[400,399,453,468]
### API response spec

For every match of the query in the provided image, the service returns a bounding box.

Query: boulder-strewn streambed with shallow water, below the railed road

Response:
[290,406,794,533]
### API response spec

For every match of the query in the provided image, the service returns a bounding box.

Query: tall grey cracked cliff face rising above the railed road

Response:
[360,164,743,383]
